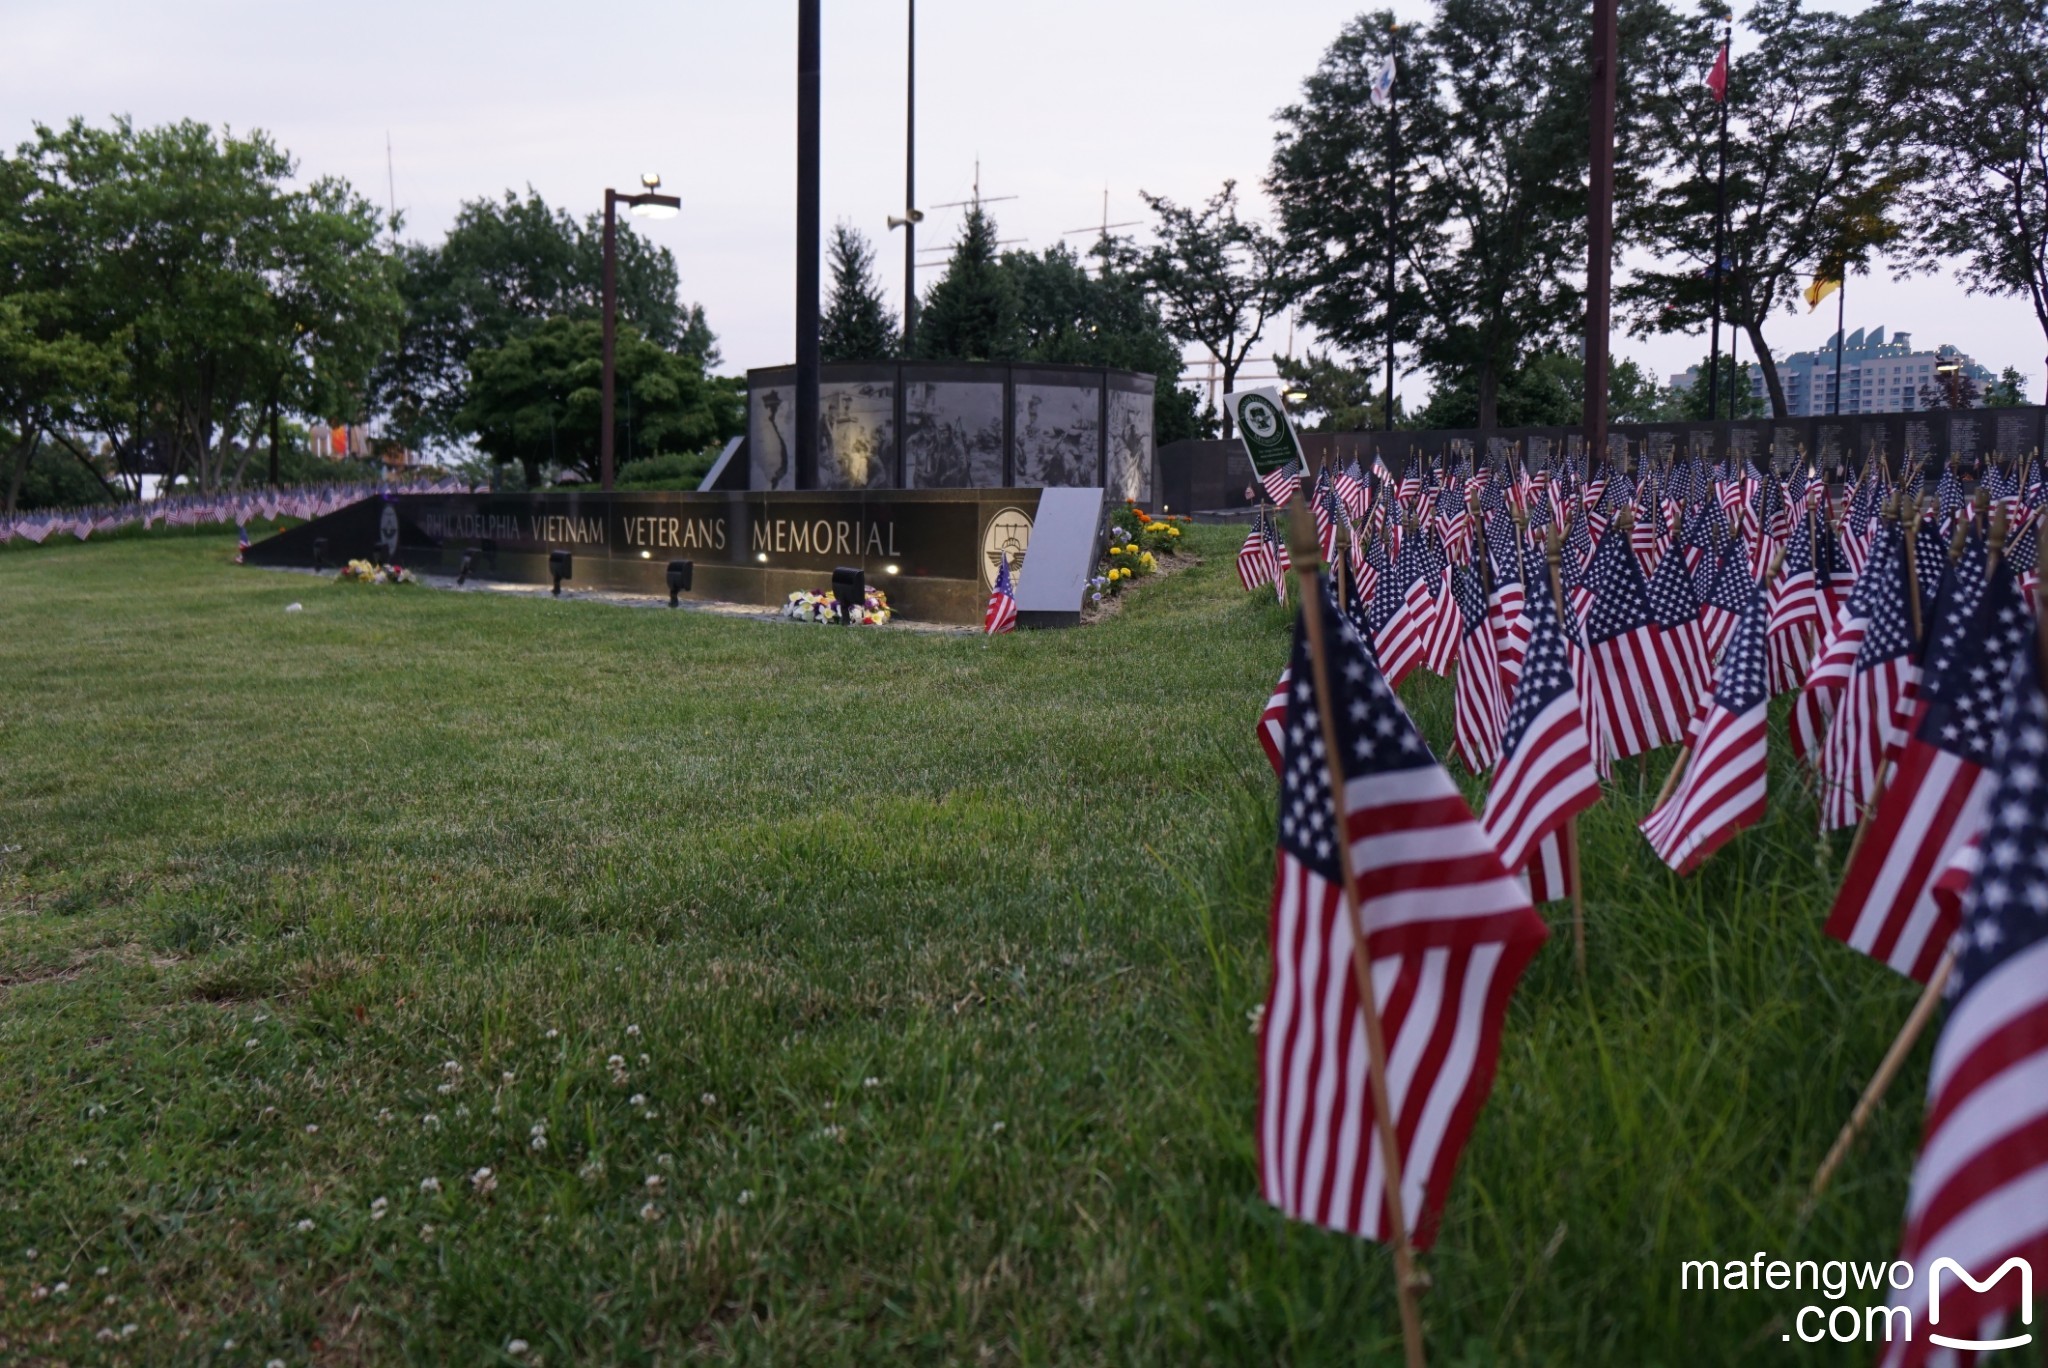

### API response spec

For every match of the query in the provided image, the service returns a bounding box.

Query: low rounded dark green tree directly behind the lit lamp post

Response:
[457,317,743,487]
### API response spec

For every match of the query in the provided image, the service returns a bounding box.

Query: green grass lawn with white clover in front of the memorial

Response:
[0,528,1990,1366]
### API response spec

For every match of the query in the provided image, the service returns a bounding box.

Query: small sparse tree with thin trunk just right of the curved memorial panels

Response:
[1133,180,1294,436]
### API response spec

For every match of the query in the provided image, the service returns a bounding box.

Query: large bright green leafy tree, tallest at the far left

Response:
[20,119,397,489]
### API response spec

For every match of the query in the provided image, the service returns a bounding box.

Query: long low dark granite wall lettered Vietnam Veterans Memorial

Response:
[244,489,1040,625]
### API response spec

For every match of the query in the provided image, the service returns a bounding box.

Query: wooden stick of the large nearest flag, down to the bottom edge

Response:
[1288,504,1423,1368]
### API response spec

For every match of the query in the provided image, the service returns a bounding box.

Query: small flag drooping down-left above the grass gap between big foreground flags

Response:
[1642,573,1772,874]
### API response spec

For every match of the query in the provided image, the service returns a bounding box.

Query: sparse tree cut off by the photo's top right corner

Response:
[1878,0,2048,395]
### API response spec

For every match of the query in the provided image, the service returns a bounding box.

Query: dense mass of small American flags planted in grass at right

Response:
[1231,391,2048,1364]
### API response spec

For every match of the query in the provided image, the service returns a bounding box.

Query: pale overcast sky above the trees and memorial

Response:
[0,0,2044,399]
